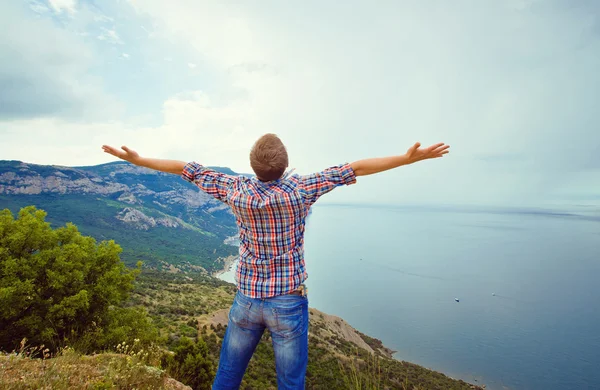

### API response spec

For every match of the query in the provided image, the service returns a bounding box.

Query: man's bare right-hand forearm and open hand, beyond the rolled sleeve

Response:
[350,142,450,176]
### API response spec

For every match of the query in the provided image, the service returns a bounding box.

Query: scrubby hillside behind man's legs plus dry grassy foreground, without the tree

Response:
[0,271,484,390]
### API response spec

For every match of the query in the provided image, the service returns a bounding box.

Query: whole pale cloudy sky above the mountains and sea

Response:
[0,0,600,206]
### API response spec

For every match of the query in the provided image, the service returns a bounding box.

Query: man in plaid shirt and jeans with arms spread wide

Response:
[103,134,449,389]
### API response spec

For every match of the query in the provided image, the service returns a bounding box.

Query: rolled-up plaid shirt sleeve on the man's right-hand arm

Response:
[300,164,356,205]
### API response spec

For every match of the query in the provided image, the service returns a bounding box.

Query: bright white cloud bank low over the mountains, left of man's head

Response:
[0,91,254,171]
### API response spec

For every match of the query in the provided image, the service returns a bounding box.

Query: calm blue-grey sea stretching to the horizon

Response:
[222,206,600,390]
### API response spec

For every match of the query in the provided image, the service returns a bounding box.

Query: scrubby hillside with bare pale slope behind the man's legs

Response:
[130,272,482,390]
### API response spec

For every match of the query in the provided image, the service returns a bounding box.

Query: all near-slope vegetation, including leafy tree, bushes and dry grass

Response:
[0,207,478,390]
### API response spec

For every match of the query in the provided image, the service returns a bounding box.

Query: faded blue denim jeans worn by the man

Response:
[213,291,308,390]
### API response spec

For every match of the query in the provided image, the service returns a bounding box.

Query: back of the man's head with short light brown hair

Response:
[250,133,288,181]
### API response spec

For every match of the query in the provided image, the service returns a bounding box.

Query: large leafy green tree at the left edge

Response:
[0,206,139,350]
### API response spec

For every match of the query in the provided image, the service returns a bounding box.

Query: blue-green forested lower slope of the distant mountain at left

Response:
[0,194,237,272]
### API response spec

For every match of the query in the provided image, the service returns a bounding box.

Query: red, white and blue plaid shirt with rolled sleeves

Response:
[182,162,356,298]
